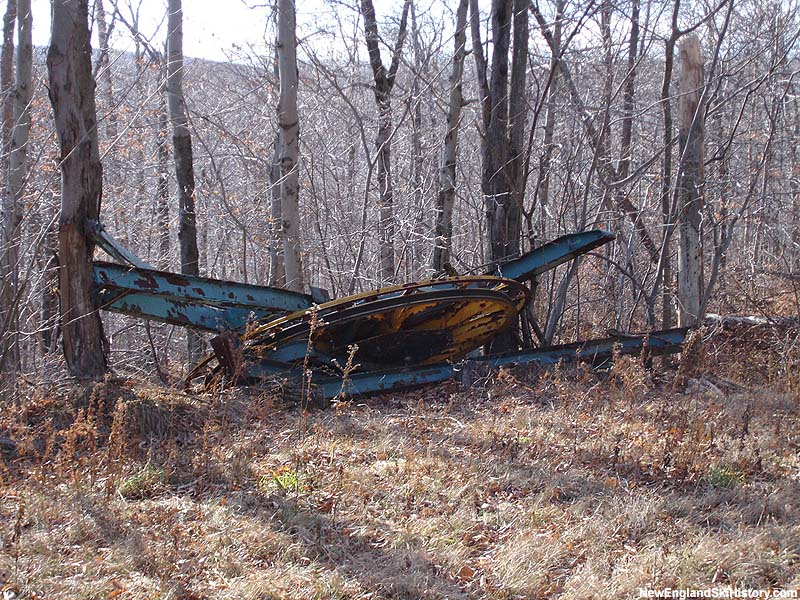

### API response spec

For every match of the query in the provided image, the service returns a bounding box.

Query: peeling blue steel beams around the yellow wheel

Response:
[87,221,687,399]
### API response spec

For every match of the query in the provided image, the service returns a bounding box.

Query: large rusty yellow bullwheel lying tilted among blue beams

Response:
[190,276,529,378]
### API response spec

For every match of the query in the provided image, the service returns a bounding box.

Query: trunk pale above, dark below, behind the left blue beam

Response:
[167,0,201,362]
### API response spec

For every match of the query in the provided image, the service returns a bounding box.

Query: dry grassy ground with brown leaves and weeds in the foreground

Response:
[0,324,800,600]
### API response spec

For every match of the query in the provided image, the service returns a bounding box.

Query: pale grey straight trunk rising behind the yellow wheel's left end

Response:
[278,0,303,292]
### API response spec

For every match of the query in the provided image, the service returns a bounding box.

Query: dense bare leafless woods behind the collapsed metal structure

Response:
[0,0,800,379]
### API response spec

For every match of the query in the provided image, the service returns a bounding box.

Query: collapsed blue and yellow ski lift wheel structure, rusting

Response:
[89,222,686,398]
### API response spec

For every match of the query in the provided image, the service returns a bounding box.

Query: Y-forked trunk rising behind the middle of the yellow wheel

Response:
[361,0,411,284]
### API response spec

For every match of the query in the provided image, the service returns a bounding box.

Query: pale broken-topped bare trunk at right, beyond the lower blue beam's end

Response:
[678,35,704,327]
